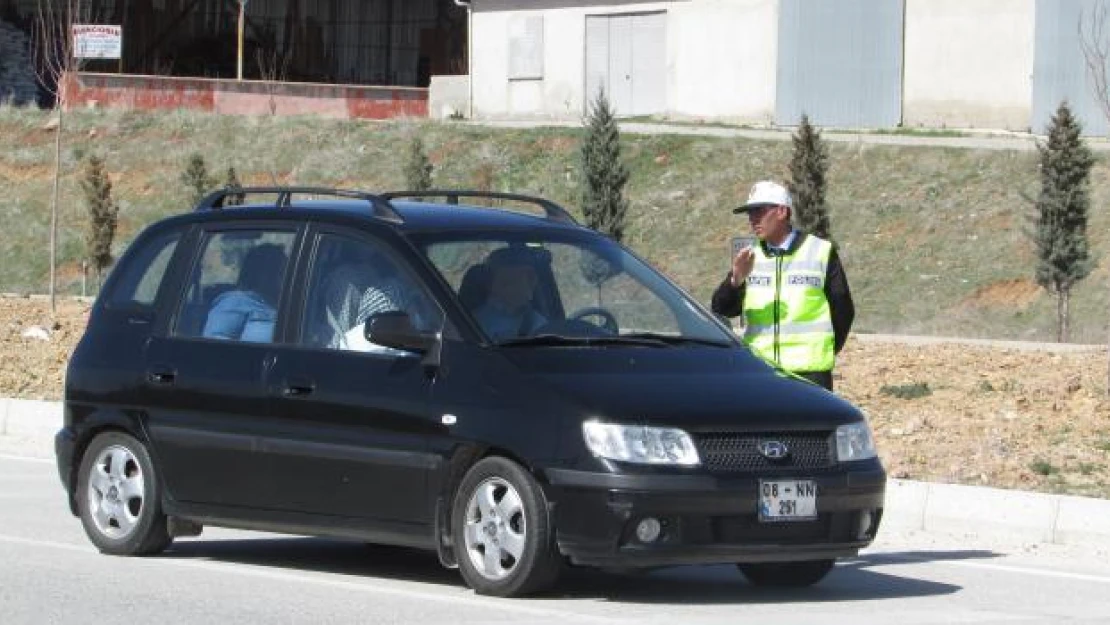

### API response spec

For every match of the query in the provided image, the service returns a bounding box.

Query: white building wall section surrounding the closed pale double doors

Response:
[472,0,778,123]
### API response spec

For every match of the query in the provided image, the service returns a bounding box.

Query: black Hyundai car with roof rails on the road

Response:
[56,188,886,596]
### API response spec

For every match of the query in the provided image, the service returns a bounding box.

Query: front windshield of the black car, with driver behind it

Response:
[418,232,735,346]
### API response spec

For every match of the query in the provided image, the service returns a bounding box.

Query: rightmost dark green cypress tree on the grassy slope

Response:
[1032,102,1094,342]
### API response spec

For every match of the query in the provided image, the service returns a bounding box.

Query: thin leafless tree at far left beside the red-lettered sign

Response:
[31,0,90,313]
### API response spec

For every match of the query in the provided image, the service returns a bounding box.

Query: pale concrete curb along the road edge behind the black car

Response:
[0,399,1110,547]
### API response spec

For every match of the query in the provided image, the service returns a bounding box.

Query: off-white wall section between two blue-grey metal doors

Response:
[902,0,1036,130]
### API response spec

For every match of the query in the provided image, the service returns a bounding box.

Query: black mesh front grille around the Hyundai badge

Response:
[694,432,834,473]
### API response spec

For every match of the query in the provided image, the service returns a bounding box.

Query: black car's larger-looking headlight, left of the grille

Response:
[582,421,699,466]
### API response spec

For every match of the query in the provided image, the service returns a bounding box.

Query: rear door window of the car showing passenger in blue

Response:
[174,230,296,343]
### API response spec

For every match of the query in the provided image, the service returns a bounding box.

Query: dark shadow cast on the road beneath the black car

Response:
[163,537,999,604]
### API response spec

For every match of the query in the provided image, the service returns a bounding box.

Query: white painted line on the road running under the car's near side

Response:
[0,534,632,625]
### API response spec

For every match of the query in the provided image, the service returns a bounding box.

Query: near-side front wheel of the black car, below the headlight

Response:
[451,456,562,597]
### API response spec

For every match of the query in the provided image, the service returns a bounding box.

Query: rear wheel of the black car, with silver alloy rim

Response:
[77,432,173,555]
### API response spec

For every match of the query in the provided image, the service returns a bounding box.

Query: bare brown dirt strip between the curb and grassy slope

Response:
[0,296,1110,497]
